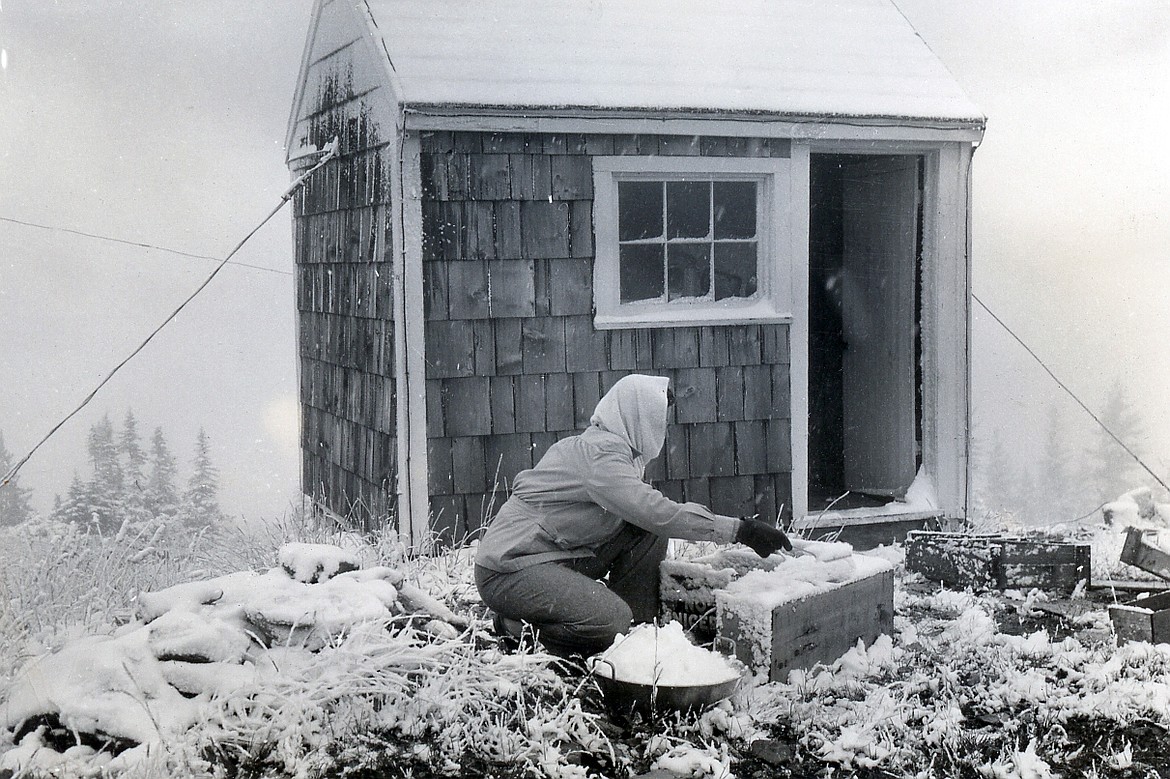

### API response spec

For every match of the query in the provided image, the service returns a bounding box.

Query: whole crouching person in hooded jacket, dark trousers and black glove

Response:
[475,374,792,656]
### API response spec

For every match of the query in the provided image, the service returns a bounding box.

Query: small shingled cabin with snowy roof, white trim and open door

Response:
[288,0,985,543]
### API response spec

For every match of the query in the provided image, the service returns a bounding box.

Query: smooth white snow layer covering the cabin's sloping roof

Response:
[365,0,984,123]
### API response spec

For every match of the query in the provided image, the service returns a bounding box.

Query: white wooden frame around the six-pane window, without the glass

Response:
[593,156,800,330]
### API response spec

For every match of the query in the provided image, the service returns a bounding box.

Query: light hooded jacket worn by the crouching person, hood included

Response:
[475,374,739,573]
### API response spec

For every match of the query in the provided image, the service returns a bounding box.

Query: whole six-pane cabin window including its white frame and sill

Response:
[594,157,791,328]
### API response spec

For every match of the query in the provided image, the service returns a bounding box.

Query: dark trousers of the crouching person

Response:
[475,523,669,655]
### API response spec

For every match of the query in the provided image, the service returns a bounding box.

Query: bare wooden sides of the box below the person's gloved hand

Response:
[716,570,894,682]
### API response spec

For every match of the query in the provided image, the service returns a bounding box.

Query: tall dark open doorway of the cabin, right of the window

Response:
[808,154,923,512]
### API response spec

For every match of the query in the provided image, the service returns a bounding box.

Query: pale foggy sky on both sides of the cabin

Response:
[0,0,1170,517]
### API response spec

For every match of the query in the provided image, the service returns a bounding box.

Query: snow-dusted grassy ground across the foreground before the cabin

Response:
[0,491,1170,779]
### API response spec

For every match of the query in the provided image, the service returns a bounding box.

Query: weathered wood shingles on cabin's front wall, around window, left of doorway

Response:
[420,132,792,539]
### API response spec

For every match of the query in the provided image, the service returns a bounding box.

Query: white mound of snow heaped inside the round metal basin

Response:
[594,622,739,687]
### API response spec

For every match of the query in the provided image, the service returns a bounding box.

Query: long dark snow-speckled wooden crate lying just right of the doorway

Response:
[906,530,1092,593]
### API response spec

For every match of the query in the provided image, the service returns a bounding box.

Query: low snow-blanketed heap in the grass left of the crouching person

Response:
[0,544,466,774]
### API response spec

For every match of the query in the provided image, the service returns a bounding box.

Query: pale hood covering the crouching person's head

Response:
[590,373,670,471]
